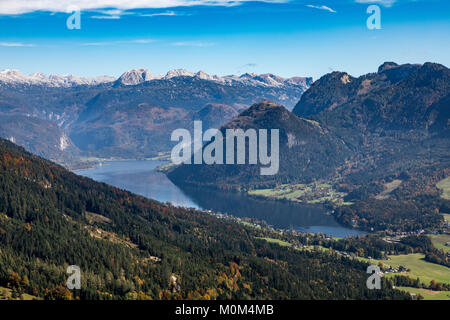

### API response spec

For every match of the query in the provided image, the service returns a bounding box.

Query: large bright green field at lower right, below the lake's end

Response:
[360,253,450,285]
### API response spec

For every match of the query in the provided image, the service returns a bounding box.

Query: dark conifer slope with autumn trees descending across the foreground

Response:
[0,140,406,299]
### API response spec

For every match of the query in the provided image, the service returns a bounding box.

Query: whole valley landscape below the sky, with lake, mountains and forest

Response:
[0,63,450,299]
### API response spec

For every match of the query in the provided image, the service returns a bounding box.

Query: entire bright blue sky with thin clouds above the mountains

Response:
[0,0,450,79]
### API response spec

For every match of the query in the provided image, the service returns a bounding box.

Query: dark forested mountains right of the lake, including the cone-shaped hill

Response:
[168,62,450,231]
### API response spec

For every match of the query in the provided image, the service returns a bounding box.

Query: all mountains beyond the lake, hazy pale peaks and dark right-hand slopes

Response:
[0,62,450,230]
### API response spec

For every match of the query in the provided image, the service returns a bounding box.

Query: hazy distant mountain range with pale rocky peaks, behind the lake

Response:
[0,69,312,164]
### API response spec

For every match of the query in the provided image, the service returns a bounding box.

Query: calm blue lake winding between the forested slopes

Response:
[76,160,364,237]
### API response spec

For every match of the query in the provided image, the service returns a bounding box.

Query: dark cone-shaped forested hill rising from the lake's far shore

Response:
[169,101,349,189]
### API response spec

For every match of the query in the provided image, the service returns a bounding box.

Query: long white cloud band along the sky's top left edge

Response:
[0,0,290,15]
